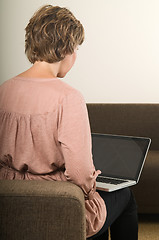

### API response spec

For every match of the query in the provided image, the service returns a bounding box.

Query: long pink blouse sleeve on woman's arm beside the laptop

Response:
[58,91,100,199]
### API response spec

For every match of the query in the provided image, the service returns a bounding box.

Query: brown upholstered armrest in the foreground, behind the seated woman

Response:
[0,180,86,240]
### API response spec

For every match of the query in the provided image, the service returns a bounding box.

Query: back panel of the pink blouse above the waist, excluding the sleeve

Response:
[0,77,78,178]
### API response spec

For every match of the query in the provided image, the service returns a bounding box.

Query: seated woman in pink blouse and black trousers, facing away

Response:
[0,5,137,239]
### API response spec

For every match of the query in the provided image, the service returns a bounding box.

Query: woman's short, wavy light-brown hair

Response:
[25,5,84,63]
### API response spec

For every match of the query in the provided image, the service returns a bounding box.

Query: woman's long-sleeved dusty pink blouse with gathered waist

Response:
[0,77,106,237]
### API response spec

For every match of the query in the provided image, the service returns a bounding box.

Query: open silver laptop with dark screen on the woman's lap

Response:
[92,133,151,192]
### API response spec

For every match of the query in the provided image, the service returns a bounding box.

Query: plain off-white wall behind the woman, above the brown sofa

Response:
[0,0,159,103]
